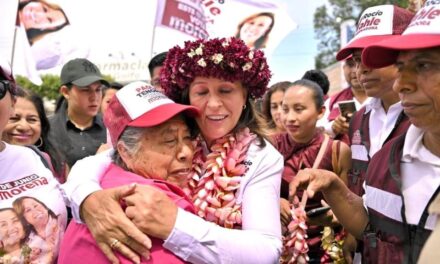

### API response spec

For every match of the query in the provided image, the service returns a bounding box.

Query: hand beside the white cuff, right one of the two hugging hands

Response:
[124,185,177,240]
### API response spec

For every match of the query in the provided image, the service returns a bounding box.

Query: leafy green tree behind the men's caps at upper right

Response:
[314,0,408,69]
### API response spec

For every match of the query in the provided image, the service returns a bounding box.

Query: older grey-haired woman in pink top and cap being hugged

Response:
[59,82,198,263]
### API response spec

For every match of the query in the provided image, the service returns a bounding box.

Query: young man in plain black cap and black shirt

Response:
[49,59,108,167]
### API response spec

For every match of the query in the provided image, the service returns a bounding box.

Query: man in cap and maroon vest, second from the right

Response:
[333,5,414,195]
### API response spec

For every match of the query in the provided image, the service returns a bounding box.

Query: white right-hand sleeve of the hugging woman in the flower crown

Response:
[164,145,283,263]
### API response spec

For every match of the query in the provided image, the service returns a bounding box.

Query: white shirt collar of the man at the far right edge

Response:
[402,125,440,166]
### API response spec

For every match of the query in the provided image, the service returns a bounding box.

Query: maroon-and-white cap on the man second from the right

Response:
[336,5,414,61]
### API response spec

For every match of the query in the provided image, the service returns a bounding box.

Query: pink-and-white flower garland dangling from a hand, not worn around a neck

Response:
[280,192,309,264]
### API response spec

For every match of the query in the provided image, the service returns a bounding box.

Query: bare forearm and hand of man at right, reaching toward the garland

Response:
[290,169,368,239]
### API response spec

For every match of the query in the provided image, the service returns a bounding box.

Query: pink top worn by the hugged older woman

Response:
[58,163,195,264]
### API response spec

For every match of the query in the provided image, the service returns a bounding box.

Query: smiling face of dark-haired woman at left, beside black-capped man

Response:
[2,97,41,145]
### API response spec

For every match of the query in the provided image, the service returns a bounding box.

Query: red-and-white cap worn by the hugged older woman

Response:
[104,82,199,146]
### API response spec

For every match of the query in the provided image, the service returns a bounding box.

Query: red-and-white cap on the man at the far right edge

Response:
[362,1,440,68]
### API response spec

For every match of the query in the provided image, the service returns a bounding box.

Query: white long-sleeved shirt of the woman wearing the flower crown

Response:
[63,141,284,263]
